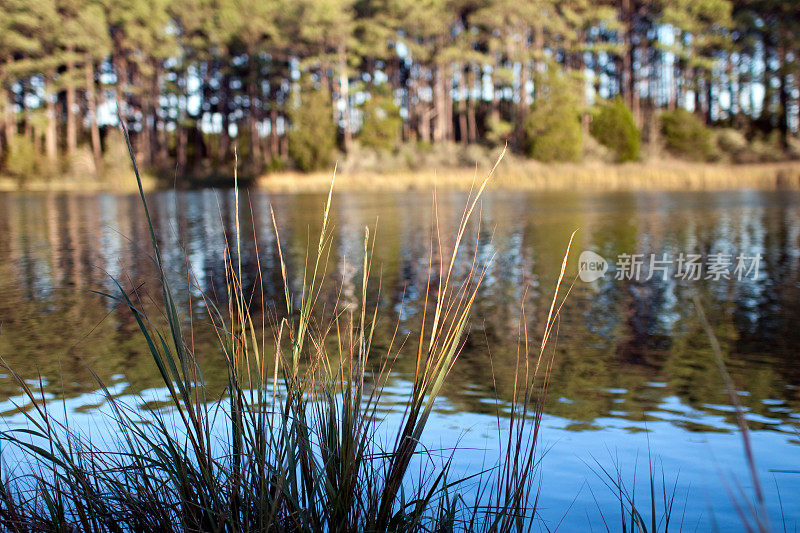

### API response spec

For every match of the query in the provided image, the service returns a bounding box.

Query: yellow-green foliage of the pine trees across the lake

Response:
[0,0,800,181]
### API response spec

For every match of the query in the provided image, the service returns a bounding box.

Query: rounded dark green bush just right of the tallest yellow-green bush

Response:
[592,97,642,163]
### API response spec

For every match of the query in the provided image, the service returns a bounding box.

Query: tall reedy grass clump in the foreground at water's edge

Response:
[0,128,566,532]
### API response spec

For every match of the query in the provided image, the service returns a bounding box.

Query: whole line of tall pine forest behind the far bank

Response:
[0,0,800,178]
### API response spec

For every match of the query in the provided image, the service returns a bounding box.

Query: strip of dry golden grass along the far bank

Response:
[0,159,800,194]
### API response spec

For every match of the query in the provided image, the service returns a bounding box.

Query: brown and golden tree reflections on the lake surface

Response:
[0,190,800,524]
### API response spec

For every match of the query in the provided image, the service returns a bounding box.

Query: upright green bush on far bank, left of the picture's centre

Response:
[289,89,336,172]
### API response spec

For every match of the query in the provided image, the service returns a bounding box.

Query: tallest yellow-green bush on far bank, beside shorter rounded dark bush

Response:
[525,70,583,162]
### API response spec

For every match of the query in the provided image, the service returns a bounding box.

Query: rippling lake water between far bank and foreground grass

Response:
[0,190,800,531]
